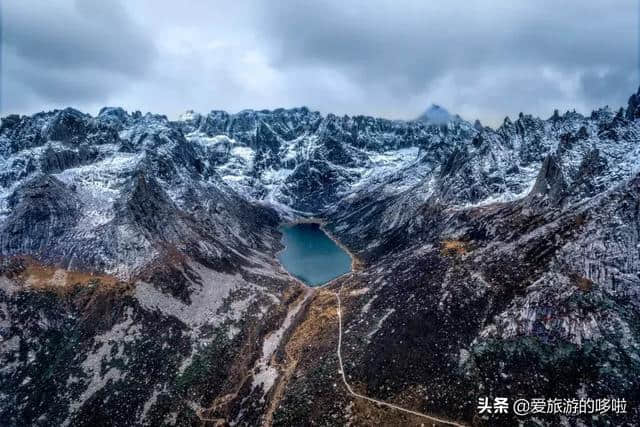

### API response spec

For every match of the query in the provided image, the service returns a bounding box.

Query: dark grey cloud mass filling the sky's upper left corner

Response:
[2,1,155,111]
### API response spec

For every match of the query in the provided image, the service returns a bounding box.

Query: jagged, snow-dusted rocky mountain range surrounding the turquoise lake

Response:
[0,91,640,425]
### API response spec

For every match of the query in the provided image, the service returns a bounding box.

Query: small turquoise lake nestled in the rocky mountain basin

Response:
[278,223,351,286]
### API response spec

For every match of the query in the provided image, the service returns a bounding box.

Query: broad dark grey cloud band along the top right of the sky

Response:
[262,0,637,77]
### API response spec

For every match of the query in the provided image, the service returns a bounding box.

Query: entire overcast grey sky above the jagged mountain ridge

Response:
[0,0,640,124]
